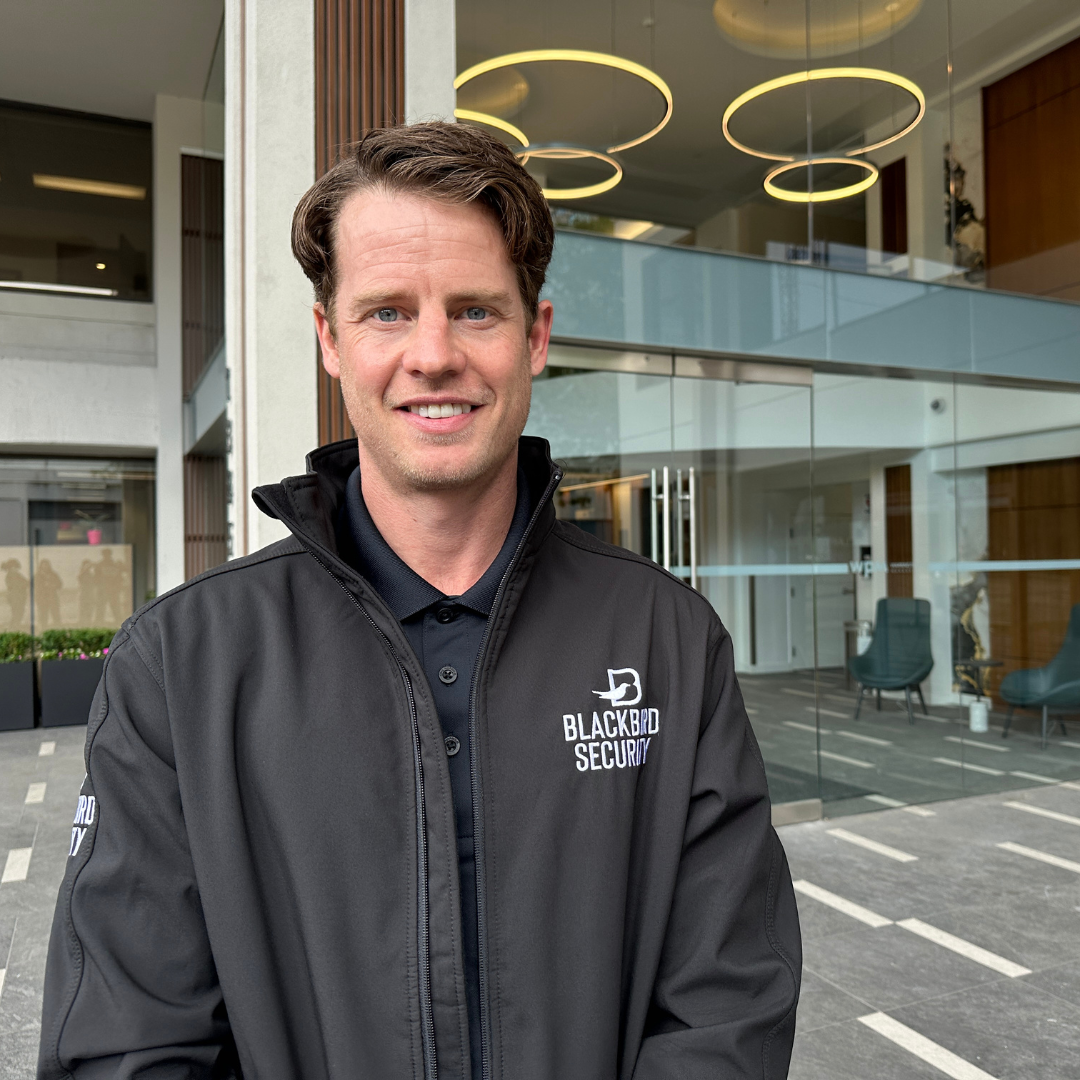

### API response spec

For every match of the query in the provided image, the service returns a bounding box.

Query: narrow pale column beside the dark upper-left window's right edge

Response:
[153,94,203,594]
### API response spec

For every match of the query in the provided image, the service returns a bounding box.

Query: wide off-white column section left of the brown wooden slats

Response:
[225,0,318,555]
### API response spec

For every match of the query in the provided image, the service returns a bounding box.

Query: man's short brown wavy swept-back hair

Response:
[293,121,555,328]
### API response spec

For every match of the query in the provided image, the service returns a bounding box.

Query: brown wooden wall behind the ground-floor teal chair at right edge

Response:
[986,458,1080,690]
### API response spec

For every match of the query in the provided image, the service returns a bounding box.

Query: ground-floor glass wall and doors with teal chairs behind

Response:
[527,346,1080,815]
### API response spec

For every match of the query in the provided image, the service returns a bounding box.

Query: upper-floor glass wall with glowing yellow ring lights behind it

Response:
[457,0,1080,300]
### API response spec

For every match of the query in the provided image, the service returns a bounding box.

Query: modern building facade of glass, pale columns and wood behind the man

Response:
[0,0,1080,815]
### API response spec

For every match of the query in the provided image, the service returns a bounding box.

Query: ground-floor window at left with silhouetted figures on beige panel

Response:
[0,458,156,634]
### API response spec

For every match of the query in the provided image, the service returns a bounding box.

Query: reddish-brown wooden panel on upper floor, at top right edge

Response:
[983,38,1080,299]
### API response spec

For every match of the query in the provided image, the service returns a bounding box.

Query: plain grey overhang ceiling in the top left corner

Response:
[0,0,224,120]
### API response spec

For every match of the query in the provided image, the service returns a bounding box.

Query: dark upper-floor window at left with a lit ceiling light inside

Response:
[0,103,153,300]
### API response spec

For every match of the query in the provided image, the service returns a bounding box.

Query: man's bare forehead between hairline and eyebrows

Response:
[335,188,514,286]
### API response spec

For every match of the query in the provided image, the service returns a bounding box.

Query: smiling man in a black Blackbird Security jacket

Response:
[39,123,800,1080]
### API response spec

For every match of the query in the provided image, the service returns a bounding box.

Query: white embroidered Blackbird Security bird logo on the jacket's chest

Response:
[563,667,660,772]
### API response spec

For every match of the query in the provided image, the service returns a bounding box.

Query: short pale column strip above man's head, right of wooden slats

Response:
[405,0,457,124]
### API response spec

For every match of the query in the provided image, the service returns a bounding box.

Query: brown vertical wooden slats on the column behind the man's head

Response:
[314,0,405,445]
